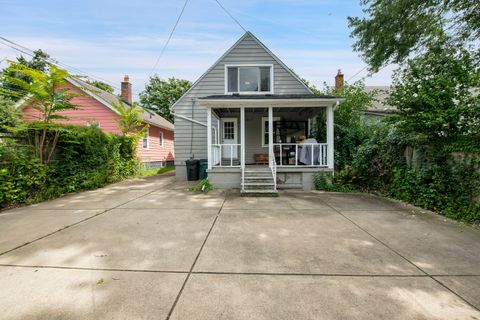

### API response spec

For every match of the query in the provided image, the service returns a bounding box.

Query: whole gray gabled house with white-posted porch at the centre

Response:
[171,32,341,192]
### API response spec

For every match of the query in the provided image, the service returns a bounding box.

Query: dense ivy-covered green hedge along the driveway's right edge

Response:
[335,123,480,223]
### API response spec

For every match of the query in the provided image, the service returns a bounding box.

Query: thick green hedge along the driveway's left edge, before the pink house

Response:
[0,124,138,208]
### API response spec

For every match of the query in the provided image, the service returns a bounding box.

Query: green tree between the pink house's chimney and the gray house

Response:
[140,75,192,122]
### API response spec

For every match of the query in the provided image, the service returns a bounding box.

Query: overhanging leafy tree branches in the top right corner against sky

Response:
[348,0,480,72]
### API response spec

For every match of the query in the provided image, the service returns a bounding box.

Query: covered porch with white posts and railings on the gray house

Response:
[205,99,337,190]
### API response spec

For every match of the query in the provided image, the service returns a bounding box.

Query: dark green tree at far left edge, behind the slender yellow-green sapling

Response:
[0,49,50,101]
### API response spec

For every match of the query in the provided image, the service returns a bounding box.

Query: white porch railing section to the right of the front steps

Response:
[270,143,328,167]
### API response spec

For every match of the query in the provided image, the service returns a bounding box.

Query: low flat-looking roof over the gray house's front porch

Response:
[198,94,344,107]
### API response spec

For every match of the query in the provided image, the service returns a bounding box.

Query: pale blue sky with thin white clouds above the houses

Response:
[0,0,393,99]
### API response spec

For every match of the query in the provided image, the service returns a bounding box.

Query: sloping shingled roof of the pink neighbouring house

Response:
[66,78,174,131]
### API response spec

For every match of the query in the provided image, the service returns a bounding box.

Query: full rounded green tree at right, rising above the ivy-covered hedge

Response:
[388,42,480,145]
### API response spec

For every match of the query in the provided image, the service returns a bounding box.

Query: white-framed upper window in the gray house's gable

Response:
[225,65,273,94]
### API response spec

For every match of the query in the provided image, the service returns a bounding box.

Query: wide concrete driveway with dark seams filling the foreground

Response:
[0,174,480,320]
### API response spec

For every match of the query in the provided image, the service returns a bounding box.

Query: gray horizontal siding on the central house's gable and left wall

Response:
[174,34,310,170]
